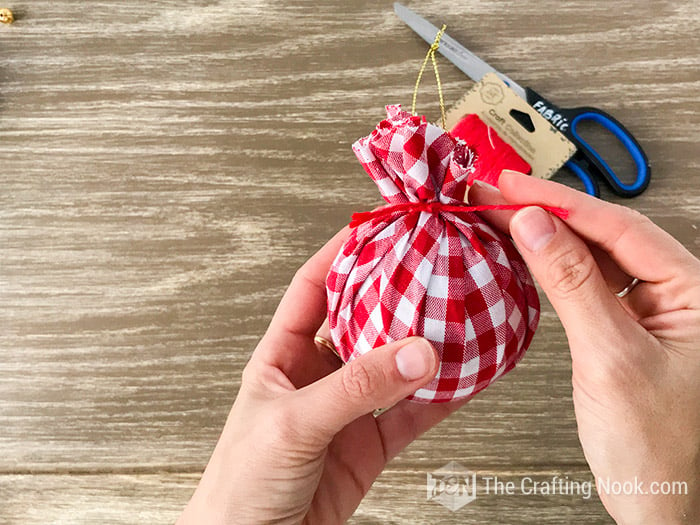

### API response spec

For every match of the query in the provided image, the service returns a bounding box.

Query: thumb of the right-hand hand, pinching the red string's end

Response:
[510,206,629,343]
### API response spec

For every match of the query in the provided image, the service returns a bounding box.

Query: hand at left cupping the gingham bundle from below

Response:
[178,229,464,525]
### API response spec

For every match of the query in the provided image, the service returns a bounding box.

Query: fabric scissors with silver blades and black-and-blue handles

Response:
[394,2,651,197]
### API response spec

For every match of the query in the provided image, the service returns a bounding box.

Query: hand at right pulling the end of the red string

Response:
[469,172,700,524]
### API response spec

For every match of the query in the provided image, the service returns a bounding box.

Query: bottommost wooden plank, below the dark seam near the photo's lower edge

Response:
[0,468,614,525]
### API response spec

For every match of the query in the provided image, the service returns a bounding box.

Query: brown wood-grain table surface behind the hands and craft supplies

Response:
[0,0,700,524]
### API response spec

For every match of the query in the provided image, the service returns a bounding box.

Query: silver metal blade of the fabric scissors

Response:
[394,2,527,100]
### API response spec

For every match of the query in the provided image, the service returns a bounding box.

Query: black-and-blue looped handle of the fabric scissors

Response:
[562,108,651,197]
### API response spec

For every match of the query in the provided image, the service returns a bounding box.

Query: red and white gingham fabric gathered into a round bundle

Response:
[326,106,539,402]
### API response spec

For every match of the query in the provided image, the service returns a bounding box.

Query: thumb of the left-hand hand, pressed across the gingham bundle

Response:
[297,337,439,441]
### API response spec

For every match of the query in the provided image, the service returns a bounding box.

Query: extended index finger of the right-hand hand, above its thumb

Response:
[499,171,697,282]
